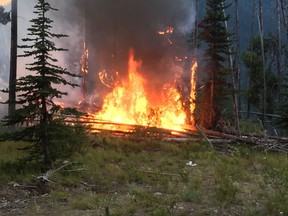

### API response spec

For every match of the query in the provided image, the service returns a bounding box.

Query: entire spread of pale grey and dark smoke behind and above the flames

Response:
[0,0,195,115]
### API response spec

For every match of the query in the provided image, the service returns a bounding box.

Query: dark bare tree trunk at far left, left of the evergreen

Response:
[8,0,18,116]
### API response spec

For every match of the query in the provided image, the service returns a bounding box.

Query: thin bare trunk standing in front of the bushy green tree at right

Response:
[258,0,267,128]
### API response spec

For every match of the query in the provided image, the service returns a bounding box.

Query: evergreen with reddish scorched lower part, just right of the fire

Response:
[198,0,231,129]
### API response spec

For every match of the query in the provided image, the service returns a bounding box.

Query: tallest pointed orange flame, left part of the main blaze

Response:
[97,48,148,125]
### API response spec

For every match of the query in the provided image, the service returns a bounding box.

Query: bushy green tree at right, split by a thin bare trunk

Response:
[242,35,278,113]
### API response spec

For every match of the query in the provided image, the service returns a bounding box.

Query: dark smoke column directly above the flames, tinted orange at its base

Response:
[67,0,195,102]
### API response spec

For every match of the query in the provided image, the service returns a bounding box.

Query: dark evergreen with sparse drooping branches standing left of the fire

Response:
[0,0,84,166]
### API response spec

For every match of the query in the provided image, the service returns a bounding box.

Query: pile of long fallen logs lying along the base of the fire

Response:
[12,116,288,153]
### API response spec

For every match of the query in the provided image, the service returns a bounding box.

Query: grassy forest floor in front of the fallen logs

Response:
[0,136,288,216]
